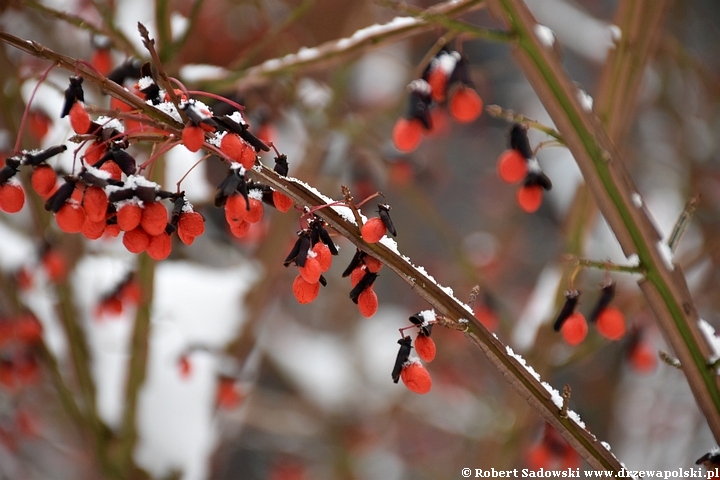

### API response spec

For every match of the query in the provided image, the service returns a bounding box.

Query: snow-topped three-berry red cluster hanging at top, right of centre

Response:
[392,49,483,153]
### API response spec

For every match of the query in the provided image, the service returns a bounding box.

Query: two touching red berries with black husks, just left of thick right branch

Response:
[498,123,552,213]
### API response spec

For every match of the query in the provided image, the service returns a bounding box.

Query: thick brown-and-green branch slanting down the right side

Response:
[488,0,720,441]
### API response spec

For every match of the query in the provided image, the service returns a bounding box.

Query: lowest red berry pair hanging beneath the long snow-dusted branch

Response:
[392,310,436,394]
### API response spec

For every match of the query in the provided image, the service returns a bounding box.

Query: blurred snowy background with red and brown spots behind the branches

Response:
[0,0,720,480]
